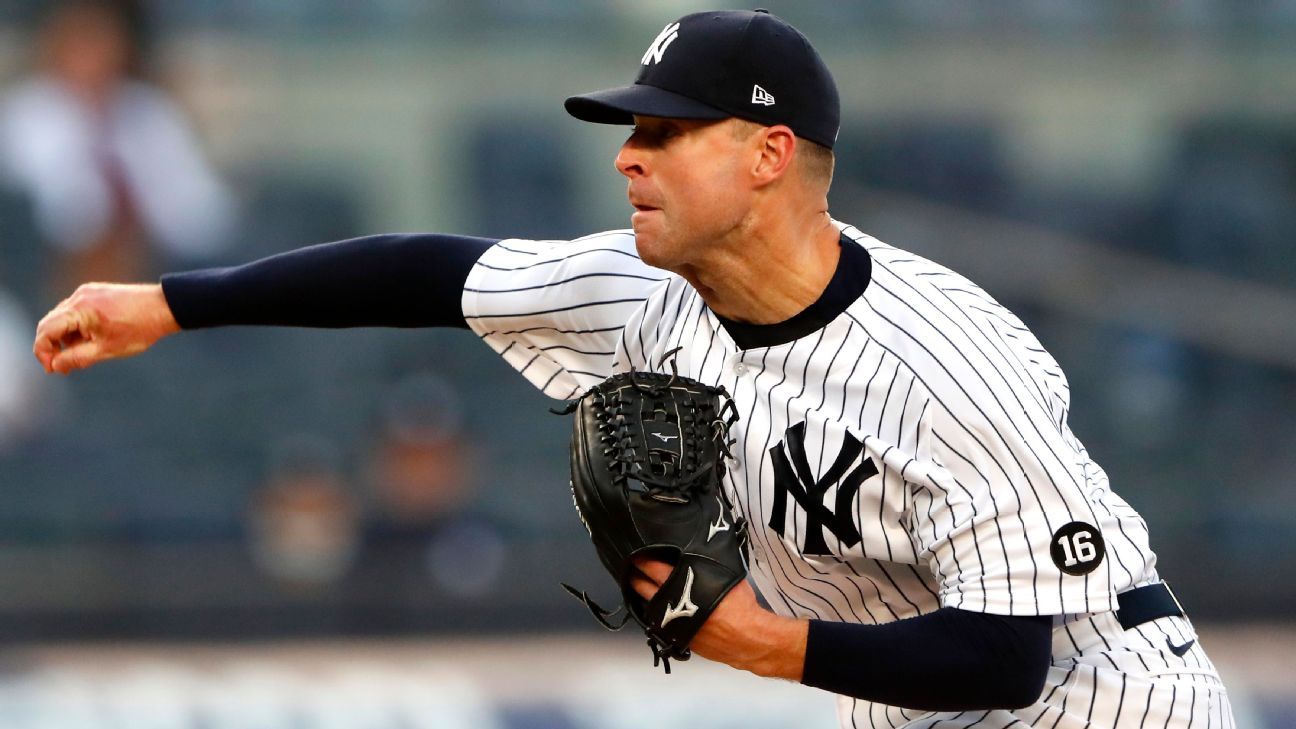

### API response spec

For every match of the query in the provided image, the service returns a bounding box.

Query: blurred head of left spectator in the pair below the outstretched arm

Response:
[250,437,359,588]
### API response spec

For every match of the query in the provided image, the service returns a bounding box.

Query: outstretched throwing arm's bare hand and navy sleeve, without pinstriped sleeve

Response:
[32,233,496,374]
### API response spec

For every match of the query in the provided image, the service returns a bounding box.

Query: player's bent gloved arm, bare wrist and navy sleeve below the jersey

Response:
[635,560,1052,711]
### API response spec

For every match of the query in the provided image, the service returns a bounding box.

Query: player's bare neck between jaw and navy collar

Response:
[679,206,841,324]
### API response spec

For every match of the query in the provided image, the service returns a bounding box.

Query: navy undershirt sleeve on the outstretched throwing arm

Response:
[162,233,498,329]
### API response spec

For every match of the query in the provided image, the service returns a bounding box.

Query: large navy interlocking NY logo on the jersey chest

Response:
[770,420,877,554]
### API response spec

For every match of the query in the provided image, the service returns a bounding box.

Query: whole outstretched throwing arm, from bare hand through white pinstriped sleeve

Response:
[34,231,666,386]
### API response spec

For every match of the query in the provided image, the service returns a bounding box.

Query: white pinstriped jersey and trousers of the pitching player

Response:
[463,226,1231,729]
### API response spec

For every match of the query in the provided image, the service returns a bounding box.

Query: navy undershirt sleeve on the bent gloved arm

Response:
[801,607,1052,711]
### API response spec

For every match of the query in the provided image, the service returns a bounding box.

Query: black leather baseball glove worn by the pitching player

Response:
[562,363,746,673]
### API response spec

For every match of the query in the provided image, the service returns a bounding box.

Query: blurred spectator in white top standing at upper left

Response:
[0,0,233,296]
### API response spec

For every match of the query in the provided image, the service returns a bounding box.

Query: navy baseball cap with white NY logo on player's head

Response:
[564,10,841,149]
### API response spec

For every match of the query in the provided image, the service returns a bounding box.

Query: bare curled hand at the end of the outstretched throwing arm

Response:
[31,284,180,375]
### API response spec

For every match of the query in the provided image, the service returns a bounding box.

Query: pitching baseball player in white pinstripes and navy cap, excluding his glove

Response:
[27,10,1234,729]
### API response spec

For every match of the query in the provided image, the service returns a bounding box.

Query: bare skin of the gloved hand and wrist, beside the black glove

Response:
[631,558,810,681]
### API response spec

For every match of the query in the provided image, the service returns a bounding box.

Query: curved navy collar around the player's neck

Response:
[713,233,874,349]
